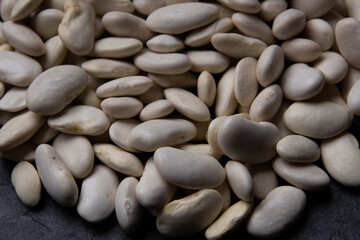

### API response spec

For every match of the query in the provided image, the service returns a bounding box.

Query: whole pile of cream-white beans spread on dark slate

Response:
[0,0,360,239]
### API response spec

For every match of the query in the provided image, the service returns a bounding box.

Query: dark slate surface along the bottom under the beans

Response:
[0,118,360,240]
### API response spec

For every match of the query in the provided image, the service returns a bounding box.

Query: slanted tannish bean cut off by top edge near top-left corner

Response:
[10,0,43,22]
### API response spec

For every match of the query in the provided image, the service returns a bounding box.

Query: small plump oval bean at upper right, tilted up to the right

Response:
[272,8,306,40]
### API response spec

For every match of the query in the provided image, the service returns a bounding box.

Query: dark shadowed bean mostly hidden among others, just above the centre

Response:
[148,72,197,89]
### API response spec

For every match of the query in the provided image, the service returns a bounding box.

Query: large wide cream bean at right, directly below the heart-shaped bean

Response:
[284,101,350,139]
